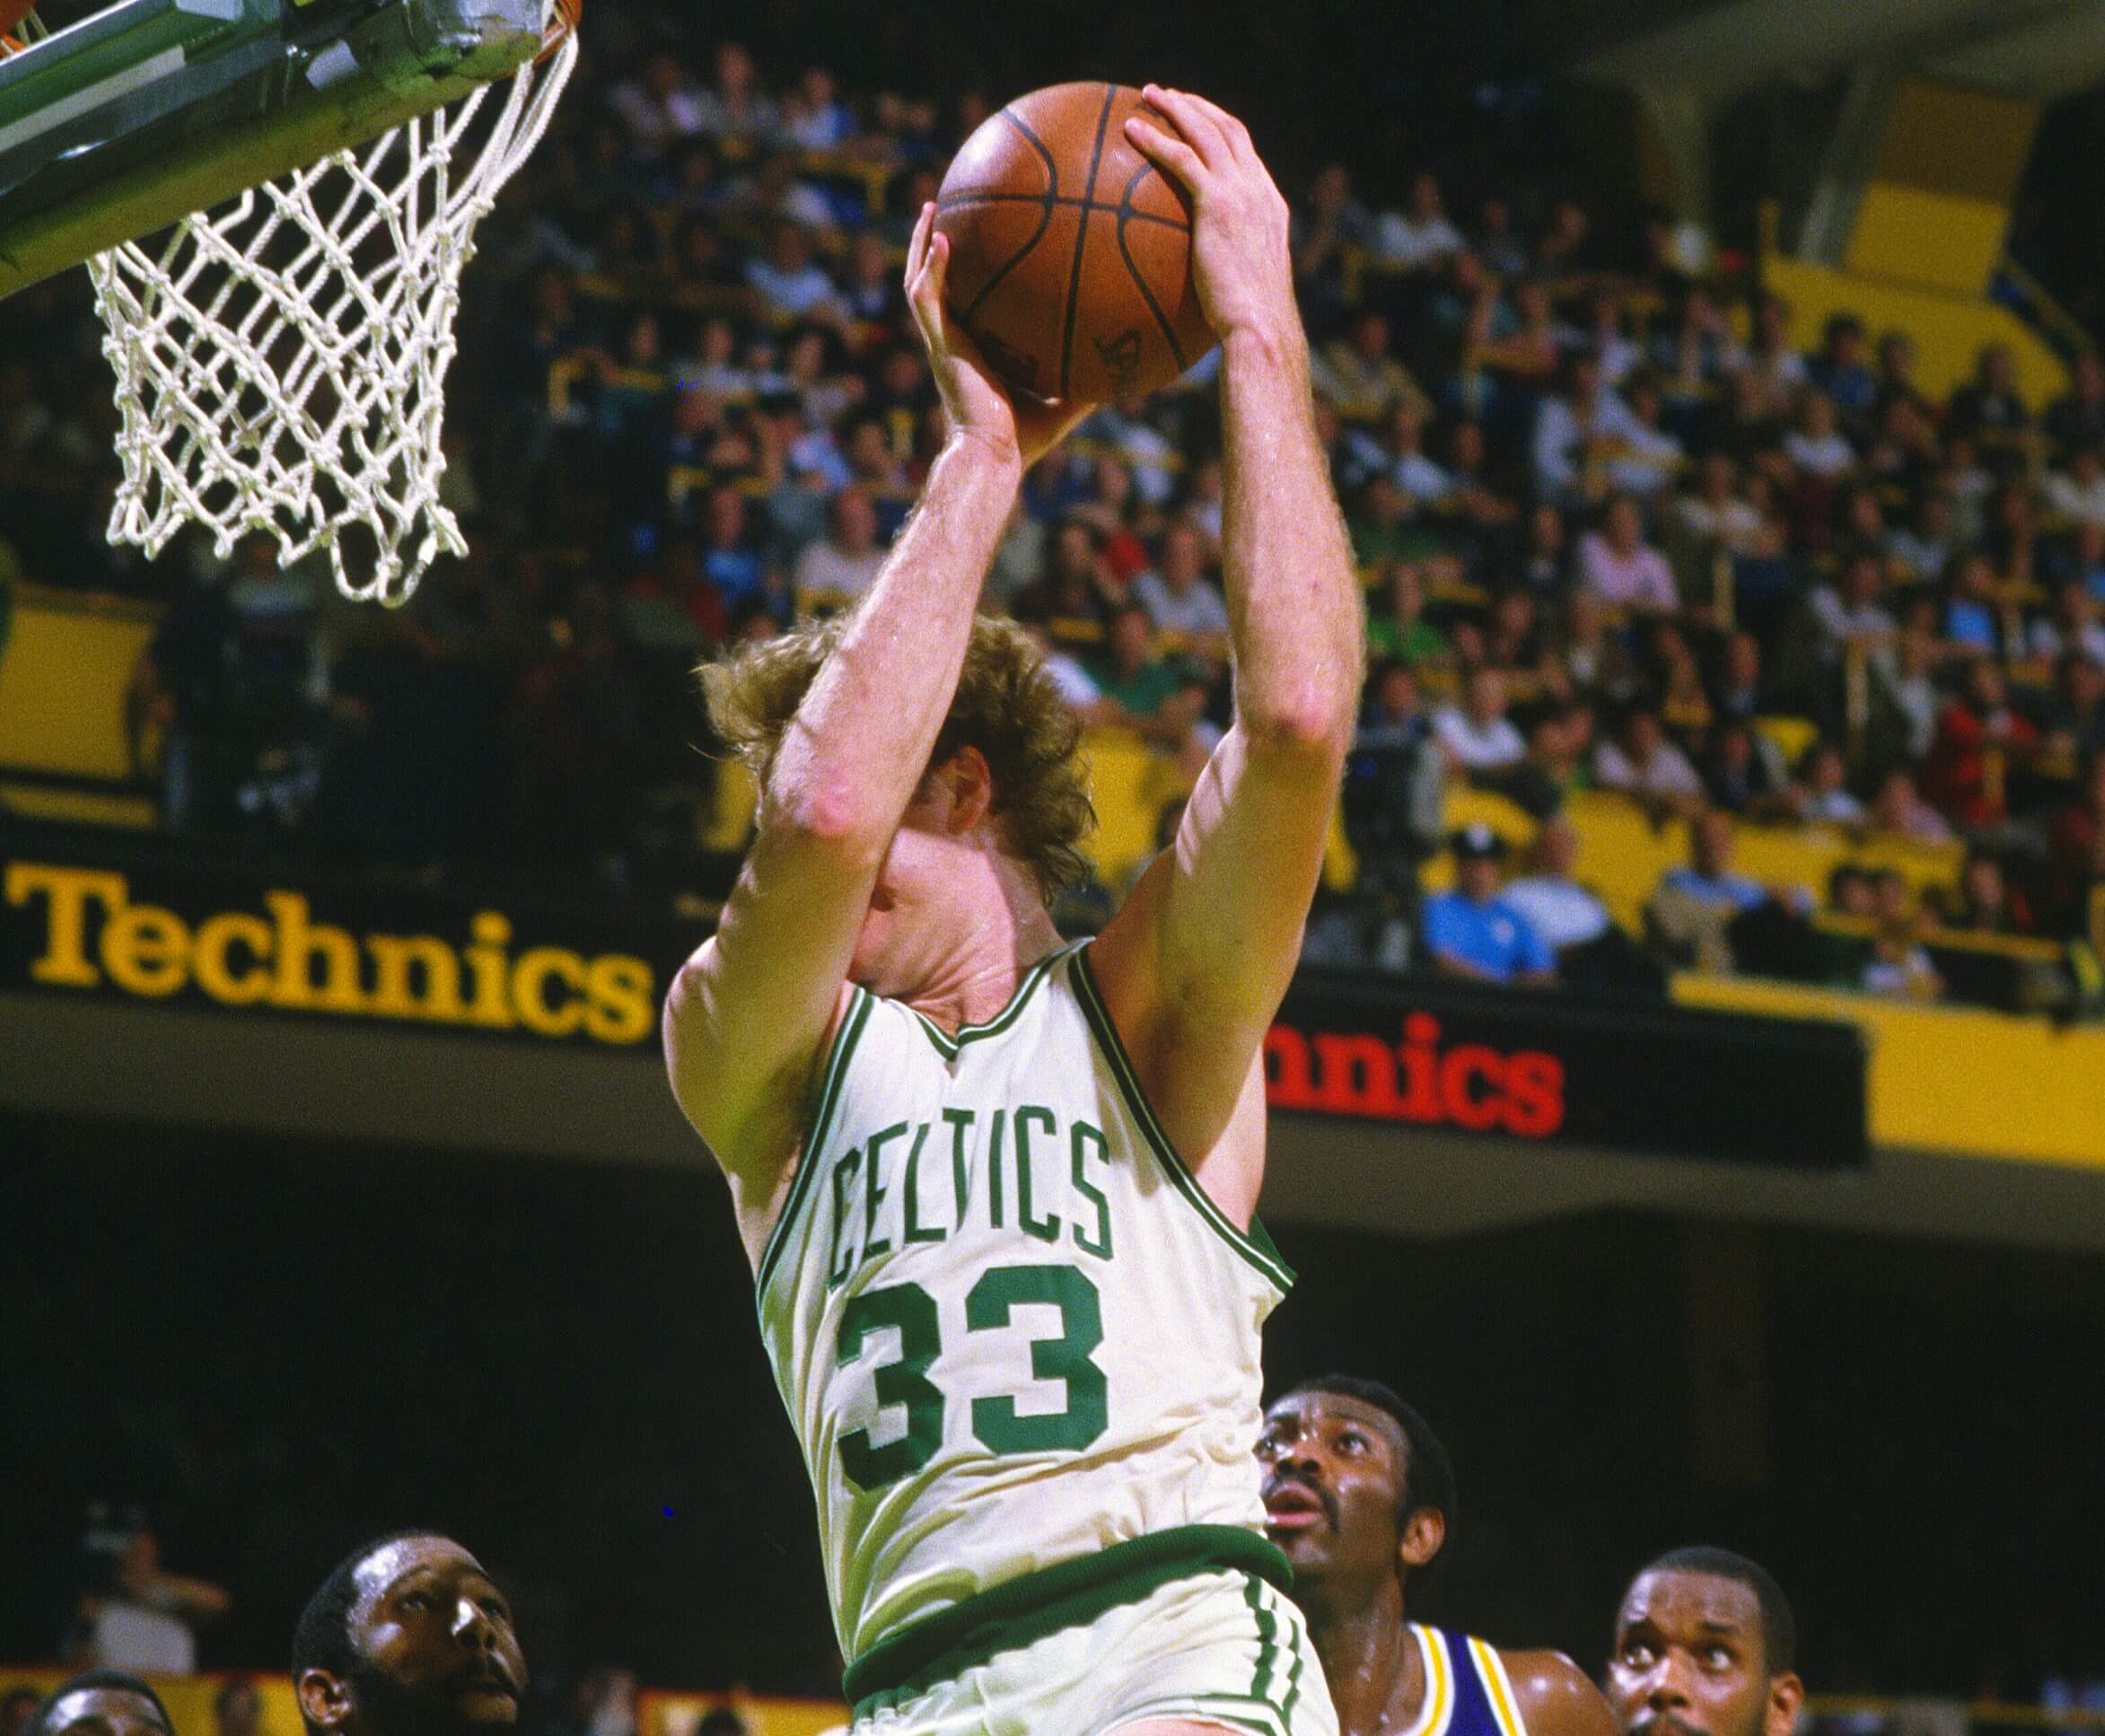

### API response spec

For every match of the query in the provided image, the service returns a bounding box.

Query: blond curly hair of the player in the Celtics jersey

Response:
[697,615,1097,903]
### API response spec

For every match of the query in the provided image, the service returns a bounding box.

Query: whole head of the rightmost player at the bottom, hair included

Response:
[1609,1548,1806,1736]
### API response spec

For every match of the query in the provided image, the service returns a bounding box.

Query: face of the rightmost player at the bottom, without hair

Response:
[1606,1570,1781,1736]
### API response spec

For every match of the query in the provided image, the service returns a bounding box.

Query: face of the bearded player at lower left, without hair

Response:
[349,1536,526,1736]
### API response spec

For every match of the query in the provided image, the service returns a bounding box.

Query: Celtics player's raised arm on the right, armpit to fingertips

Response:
[1097,86,1362,1216]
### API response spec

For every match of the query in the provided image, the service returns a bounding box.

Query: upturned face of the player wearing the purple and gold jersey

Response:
[1257,1393,1406,1581]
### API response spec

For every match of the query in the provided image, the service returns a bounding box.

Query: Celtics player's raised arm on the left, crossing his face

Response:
[665,206,1086,1241]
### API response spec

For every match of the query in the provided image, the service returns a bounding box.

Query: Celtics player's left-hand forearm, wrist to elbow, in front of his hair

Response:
[768,438,1023,848]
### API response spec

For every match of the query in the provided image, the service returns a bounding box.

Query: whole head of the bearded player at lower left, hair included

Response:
[293,1532,526,1736]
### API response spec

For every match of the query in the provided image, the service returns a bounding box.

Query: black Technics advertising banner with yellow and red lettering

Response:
[0,848,1865,1168]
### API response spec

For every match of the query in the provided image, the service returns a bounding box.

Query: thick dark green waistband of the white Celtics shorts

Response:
[840,1526,1294,1722]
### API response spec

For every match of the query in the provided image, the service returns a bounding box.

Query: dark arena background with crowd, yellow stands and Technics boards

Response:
[0,0,2105,1736]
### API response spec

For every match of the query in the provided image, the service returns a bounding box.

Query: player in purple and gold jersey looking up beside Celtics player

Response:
[1257,1374,1615,1736]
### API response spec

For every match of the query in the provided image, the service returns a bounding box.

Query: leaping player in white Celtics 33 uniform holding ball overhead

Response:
[665,88,1360,1736]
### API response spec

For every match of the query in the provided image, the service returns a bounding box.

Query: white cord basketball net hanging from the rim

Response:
[88,16,577,604]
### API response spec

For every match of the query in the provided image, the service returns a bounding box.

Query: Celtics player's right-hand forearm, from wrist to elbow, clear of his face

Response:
[1221,329,1362,747]
